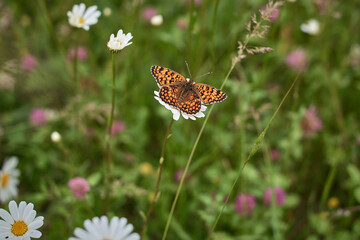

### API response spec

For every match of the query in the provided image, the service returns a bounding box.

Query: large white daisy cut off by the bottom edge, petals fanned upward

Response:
[69,216,140,240]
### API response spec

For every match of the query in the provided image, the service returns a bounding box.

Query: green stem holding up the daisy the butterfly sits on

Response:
[140,118,174,238]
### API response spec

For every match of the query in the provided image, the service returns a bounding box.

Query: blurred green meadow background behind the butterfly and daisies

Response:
[0,0,360,240]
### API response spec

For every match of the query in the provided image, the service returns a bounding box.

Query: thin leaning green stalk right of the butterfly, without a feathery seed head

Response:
[208,72,300,239]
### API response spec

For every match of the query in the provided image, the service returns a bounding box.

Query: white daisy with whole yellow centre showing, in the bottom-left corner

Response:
[0,200,44,240]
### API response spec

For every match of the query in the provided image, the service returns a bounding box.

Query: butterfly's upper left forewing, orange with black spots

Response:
[151,65,186,86]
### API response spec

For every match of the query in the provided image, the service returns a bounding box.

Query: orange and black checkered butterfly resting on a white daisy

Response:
[151,65,227,115]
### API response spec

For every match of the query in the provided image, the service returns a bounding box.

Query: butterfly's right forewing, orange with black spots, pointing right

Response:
[195,83,227,104]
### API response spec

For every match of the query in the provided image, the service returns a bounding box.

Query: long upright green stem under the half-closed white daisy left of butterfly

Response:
[103,53,116,213]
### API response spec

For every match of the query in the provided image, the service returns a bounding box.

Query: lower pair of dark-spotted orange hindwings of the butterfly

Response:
[159,84,201,114]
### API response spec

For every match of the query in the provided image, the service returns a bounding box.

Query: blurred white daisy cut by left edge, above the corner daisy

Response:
[0,157,20,203]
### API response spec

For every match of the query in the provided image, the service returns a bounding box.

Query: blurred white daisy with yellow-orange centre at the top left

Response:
[67,3,101,31]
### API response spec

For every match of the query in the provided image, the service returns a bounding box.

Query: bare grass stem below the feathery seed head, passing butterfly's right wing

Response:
[162,62,236,240]
